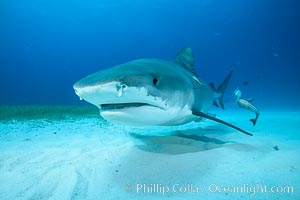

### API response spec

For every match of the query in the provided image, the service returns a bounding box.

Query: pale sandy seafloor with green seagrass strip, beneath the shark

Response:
[0,107,300,200]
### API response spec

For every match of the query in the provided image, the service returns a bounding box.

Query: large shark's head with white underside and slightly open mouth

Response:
[74,59,194,126]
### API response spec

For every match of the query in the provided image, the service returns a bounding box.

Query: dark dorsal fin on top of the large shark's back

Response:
[175,47,196,74]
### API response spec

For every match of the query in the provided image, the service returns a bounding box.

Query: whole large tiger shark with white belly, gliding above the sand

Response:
[73,47,252,135]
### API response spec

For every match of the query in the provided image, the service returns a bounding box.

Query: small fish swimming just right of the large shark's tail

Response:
[234,89,260,126]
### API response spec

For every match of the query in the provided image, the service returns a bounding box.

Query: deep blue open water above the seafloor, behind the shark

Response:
[0,0,300,109]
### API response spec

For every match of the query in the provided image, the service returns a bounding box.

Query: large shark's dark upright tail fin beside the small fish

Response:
[210,70,233,109]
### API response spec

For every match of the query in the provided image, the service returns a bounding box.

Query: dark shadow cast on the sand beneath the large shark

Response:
[130,127,235,155]
